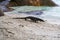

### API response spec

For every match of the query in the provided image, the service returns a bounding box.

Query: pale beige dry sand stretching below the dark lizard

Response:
[0,16,60,40]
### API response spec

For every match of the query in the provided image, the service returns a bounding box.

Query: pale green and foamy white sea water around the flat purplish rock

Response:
[5,6,60,24]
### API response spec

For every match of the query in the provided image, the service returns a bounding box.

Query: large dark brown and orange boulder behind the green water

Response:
[10,0,57,6]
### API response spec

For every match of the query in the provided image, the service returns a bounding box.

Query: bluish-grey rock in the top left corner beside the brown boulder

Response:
[0,0,13,12]
